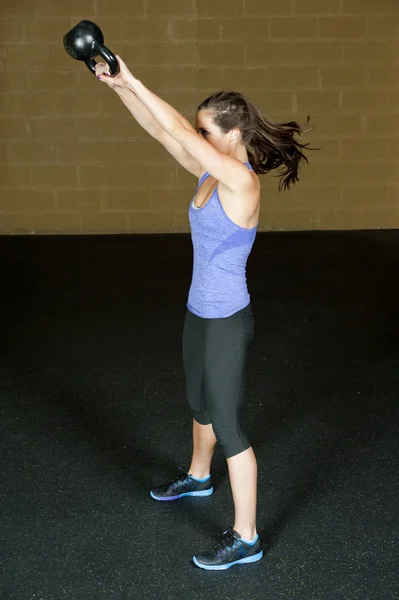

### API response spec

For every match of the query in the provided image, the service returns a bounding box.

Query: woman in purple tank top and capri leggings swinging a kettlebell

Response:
[96,57,306,570]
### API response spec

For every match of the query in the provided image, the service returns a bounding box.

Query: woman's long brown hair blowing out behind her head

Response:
[198,91,310,191]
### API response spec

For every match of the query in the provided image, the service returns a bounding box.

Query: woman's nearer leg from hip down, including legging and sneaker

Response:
[193,305,263,570]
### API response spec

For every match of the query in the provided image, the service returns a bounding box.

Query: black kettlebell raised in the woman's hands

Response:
[64,21,119,76]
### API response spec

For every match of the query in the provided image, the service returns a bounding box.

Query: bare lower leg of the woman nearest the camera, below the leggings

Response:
[227,448,258,540]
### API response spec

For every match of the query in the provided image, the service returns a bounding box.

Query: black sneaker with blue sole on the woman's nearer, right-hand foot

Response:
[193,527,263,571]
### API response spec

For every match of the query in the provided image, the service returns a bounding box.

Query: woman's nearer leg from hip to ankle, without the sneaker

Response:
[205,306,257,540]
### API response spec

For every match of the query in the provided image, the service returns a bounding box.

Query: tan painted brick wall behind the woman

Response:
[0,0,399,233]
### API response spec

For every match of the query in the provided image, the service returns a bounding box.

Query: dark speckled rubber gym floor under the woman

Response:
[0,231,399,600]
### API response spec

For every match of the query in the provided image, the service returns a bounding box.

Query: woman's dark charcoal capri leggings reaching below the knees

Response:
[183,304,254,458]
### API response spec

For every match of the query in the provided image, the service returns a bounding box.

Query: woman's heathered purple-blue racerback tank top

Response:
[187,163,257,319]
